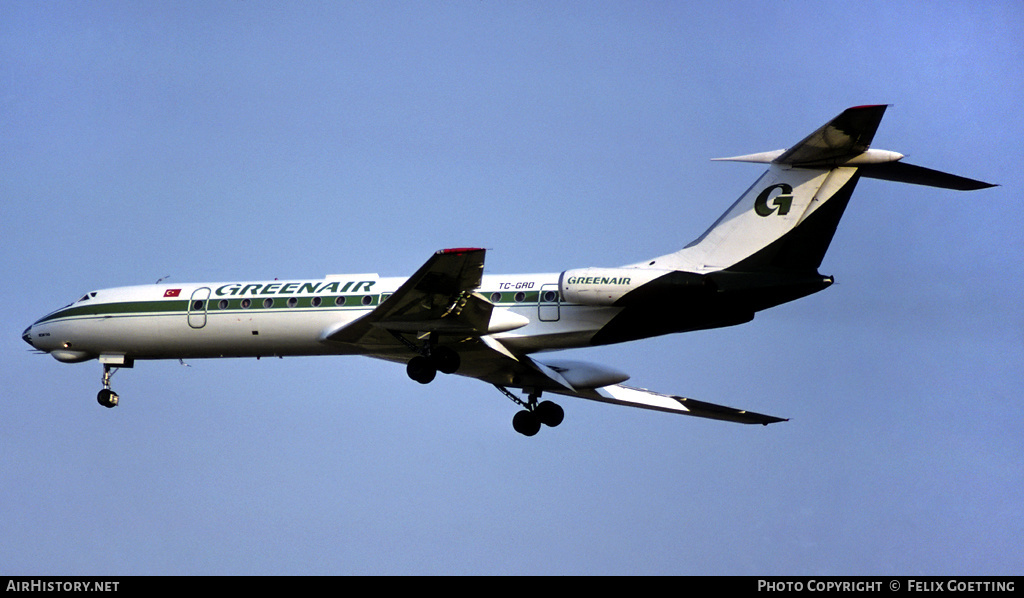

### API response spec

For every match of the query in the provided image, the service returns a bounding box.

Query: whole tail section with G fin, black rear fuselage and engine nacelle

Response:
[562,105,994,343]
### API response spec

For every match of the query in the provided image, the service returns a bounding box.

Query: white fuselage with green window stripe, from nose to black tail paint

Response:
[25,273,622,361]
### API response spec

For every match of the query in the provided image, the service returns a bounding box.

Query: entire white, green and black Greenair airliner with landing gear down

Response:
[23,105,993,436]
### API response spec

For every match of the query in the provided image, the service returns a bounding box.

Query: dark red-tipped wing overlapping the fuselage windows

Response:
[321,248,494,346]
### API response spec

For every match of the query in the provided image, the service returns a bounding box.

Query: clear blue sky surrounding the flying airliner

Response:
[0,0,1024,575]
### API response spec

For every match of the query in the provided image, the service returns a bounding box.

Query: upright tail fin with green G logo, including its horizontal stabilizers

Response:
[634,105,992,273]
